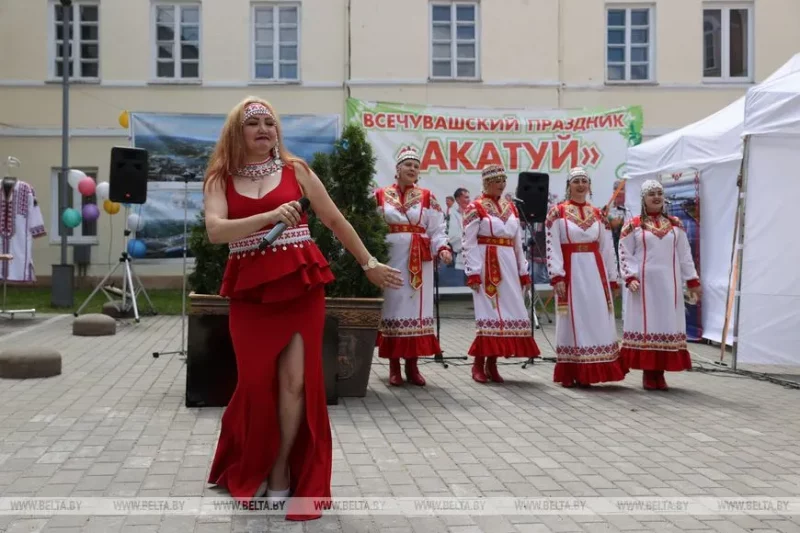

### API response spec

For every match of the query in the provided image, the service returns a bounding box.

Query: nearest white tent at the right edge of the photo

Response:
[736,68,800,366]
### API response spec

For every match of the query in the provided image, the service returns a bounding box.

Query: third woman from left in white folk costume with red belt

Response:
[545,168,627,387]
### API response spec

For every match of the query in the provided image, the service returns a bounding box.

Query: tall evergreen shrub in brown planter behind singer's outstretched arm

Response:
[309,124,388,397]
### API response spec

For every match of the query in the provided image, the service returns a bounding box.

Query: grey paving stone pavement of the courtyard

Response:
[0,316,800,533]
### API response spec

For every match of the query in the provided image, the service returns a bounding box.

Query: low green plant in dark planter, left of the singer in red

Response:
[186,212,237,407]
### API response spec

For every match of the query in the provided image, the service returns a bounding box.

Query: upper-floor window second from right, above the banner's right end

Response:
[606,7,653,82]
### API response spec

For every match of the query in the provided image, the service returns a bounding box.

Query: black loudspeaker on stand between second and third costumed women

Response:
[516,172,553,368]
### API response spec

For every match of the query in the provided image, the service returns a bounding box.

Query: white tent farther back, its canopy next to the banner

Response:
[625,54,800,342]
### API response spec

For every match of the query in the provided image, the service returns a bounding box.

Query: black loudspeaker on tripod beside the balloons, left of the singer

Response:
[108,146,150,204]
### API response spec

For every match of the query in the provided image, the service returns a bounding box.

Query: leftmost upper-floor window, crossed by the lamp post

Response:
[50,2,100,80]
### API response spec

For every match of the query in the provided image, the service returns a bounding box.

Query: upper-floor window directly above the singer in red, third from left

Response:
[253,4,300,81]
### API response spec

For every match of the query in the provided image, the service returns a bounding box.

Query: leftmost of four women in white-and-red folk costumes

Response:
[375,147,452,386]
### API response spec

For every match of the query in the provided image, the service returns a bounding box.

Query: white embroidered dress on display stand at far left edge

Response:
[0,181,47,283]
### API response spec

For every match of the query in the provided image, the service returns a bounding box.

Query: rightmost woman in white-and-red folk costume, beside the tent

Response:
[619,180,701,390]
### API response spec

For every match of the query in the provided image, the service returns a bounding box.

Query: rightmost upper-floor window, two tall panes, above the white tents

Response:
[703,6,753,81]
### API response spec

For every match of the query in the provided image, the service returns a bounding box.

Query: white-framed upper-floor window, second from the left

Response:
[150,0,203,83]
